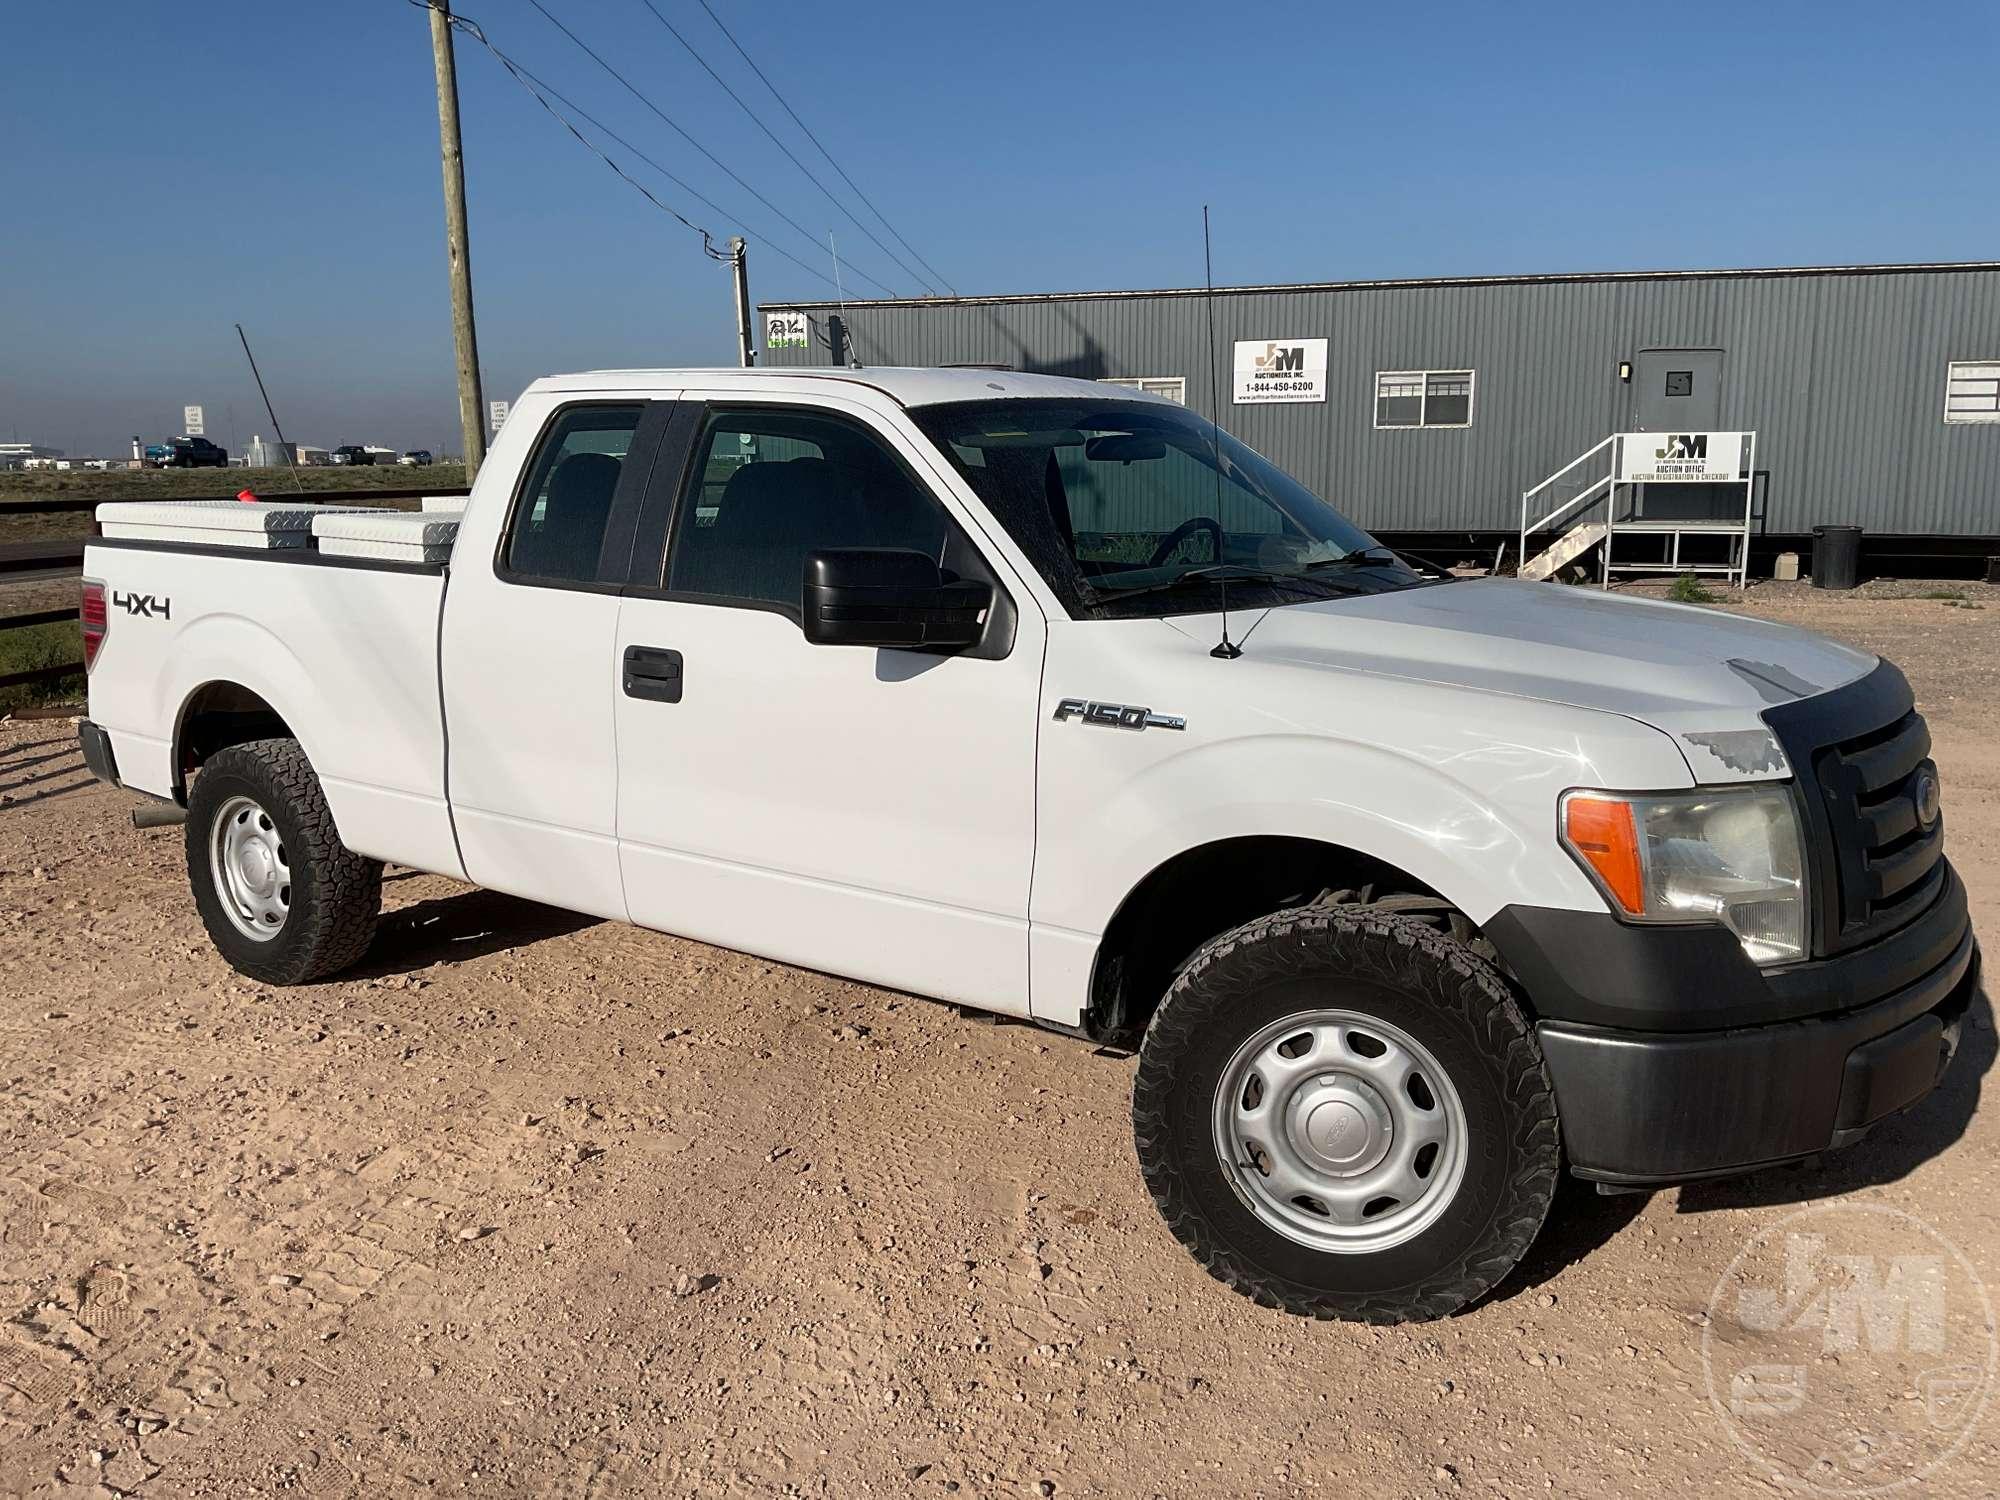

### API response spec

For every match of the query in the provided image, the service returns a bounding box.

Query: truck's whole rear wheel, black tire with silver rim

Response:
[188,740,382,984]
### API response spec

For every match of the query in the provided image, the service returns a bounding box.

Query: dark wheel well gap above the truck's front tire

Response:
[1084,834,1494,1042]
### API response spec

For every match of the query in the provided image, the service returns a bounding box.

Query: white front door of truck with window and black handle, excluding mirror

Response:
[616,404,1046,1014]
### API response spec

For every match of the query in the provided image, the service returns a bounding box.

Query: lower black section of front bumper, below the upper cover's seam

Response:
[1536,928,1980,1186]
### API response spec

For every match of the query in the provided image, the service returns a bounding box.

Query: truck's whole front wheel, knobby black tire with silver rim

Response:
[1132,906,1560,1322]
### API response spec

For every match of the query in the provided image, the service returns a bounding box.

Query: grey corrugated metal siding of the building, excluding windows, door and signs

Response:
[764,270,2000,536]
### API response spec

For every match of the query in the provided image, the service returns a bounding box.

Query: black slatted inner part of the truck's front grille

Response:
[1808,708,1944,952]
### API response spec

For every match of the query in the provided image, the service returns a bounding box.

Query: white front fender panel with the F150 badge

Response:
[1030,680,1690,1024]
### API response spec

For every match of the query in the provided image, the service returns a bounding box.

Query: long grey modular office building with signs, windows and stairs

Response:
[760,262,2000,572]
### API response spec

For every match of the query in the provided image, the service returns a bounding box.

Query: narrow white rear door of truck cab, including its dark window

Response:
[440,400,674,920]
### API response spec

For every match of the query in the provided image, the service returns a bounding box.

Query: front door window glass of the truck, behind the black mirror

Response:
[666,408,952,612]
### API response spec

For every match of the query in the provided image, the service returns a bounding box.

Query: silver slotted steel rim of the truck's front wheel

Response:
[1214,1010,1466,1254]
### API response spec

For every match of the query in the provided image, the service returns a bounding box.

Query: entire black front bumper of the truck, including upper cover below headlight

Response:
[1488,872,1980,1188]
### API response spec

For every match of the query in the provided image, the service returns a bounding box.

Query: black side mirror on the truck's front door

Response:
[804,548,994,646]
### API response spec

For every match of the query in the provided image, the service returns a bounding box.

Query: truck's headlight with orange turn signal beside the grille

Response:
[1560,786,1806,964]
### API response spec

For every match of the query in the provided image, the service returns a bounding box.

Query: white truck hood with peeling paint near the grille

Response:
[1168,578,1876,782]
